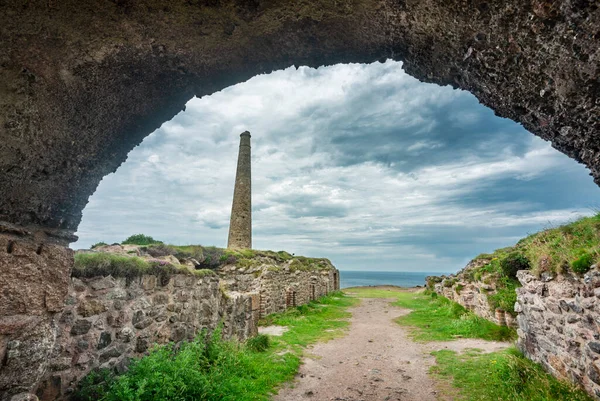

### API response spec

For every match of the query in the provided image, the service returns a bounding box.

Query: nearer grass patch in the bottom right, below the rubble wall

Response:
[431,348,592,401]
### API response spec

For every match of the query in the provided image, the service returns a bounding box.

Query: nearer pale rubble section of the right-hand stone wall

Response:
[515,266,600,399]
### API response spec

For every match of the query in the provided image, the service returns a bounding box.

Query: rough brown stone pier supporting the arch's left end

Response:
[0,233,73,400]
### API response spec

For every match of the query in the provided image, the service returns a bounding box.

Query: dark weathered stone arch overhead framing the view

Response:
[0,0,600,230]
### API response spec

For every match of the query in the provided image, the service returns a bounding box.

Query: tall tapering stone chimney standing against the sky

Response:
[227,131,252,249]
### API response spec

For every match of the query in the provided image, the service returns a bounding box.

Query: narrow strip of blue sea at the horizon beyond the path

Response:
[340,270,449,288]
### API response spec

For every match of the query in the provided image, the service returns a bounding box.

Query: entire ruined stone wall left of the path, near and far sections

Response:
[37,252,339,400]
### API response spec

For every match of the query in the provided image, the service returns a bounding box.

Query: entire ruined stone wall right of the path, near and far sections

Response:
[428,262,600,400]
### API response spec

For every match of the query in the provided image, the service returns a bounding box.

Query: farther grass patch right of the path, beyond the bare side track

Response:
[345,288,516,341]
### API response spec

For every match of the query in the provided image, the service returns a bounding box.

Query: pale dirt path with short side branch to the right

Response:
[274,298,509,401]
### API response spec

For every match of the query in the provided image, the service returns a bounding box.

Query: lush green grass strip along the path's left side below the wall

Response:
[73,293,356,401]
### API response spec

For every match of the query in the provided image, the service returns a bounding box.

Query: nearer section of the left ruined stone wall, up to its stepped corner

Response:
[37,274,258,400]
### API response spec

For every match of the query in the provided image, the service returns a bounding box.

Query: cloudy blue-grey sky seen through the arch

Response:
[72,61,600,272]
